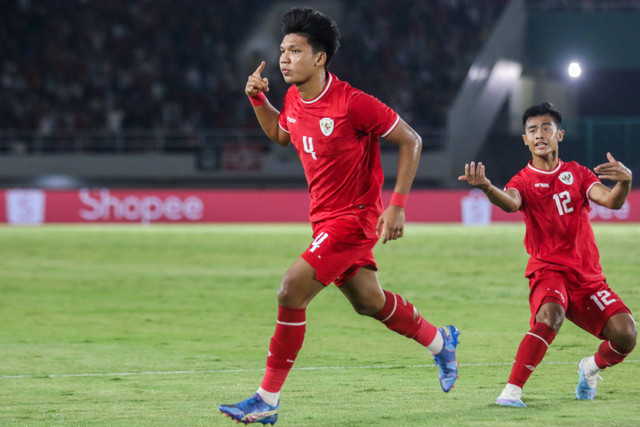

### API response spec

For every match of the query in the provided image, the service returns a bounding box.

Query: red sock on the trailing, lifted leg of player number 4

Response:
[372,291,438,347]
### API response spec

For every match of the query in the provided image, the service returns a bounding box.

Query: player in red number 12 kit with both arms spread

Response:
[458,103,637,407]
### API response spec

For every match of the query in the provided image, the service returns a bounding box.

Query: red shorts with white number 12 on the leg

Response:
[529,268,631,339]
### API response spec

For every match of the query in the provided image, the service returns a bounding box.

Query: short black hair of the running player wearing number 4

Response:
[280,7,340,68]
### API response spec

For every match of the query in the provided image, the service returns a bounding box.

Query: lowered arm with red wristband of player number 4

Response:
[376,119,422,243]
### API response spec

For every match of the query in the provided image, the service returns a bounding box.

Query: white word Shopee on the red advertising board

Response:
[79,189,204,223]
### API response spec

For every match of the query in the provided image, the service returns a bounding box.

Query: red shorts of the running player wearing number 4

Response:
[301,217,378,286]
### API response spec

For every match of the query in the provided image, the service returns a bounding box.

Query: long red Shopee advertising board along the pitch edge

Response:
[0,188,640,225]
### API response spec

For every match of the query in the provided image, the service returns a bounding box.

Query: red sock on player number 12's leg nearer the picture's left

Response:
[509,323,556,387]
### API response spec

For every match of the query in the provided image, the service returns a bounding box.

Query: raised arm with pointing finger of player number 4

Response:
[244,61,291,147]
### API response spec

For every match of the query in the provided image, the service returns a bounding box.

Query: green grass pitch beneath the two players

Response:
[0,224,640,426]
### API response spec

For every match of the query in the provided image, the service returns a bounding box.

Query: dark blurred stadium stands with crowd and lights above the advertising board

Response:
[0,0,640,189]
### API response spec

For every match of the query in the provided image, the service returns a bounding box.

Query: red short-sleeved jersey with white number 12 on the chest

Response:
[504,161,604,282]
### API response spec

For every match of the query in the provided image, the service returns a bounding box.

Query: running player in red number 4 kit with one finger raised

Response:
[220,8,459,424]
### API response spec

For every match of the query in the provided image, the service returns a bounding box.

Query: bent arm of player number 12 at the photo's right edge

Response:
[589,153,633,209]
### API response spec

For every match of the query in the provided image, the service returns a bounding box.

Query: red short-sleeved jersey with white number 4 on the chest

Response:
[279,73,400,235]
